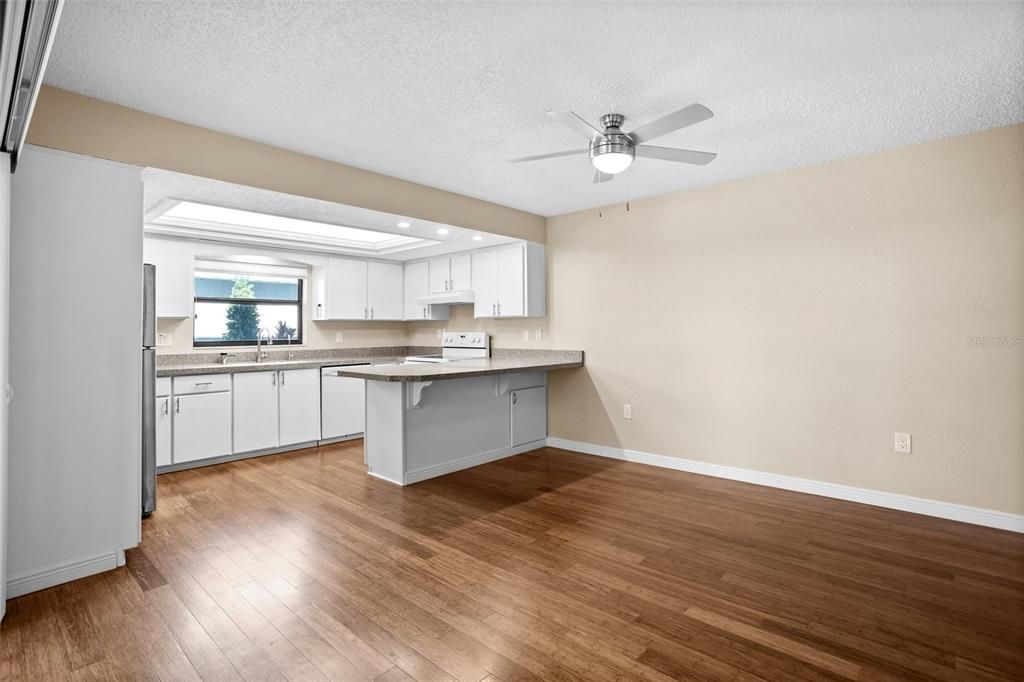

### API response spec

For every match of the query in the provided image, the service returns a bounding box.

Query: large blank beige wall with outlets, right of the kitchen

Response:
[540,125,1024,514]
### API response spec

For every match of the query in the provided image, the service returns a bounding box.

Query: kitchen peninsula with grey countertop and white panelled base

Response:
[337,350,584,485]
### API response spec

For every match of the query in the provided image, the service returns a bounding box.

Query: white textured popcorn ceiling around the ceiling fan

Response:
[46,0,1024,215]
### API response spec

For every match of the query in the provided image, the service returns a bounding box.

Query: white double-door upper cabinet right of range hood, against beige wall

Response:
[472,242,545,317]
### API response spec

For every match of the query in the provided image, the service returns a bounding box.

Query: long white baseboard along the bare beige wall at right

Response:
[548,437,1024,532]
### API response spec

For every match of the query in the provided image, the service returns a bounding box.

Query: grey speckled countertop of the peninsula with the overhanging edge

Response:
[329,350,583,382]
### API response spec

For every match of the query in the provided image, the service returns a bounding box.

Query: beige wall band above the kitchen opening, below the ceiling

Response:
[28,86,545,243]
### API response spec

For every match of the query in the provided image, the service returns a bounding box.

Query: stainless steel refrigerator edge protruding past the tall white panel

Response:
[142,263,157,517]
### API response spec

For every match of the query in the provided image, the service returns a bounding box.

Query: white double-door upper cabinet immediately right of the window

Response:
[312,258,403,319]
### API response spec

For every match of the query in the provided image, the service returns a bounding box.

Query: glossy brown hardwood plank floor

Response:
[0,442,1024,682]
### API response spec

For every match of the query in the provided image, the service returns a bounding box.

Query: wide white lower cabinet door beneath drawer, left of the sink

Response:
[172,391,231,464]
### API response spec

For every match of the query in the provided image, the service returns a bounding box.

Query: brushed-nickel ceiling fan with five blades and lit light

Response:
[509,104,718,182]
